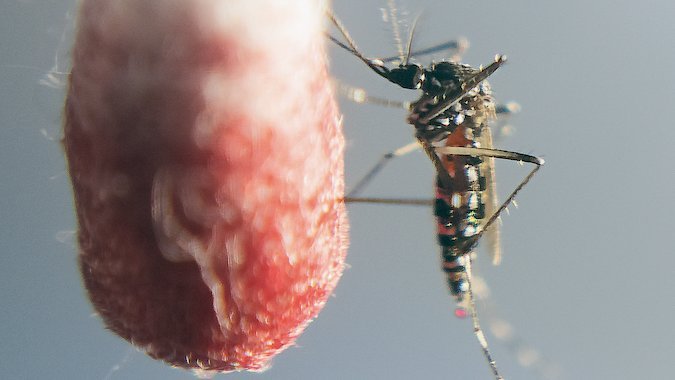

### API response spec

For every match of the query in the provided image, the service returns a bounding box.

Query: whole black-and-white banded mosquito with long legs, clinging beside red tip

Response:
[327,12,544,380]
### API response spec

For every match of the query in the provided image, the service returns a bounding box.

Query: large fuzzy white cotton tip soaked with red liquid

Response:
[64,0,347,371]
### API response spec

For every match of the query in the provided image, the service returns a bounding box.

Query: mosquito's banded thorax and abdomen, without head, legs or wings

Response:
[409,62,495,310]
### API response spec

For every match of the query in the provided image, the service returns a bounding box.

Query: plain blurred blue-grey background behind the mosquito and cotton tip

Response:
[0,0,675,379]
